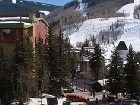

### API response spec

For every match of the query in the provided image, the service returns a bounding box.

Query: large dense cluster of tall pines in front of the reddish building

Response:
[0,24,77,105]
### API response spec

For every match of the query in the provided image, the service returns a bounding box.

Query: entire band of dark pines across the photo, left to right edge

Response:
[0,21,140,105]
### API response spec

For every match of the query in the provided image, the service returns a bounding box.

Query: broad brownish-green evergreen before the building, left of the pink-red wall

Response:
[12,35,35,104]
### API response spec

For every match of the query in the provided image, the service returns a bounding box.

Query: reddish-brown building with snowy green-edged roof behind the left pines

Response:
[0,13,48,66]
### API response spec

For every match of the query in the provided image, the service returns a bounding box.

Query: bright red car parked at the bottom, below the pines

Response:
[66,95,87,102]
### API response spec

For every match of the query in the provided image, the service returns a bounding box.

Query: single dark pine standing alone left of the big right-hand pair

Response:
[90,44,104,81]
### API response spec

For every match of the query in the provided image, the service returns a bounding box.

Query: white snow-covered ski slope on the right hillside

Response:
[65,0,140,58]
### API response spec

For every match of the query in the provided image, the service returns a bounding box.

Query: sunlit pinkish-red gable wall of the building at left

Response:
[34,20,48,44]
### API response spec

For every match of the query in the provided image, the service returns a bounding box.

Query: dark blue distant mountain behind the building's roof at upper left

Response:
[0,0,60,17]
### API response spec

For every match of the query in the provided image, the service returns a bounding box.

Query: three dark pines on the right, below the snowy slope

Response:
[86,41,140,99]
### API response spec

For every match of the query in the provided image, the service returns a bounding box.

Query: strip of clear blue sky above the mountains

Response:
[28,0,71,6]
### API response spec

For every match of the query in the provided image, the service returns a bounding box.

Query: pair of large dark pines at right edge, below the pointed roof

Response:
[107,45,140,99]
